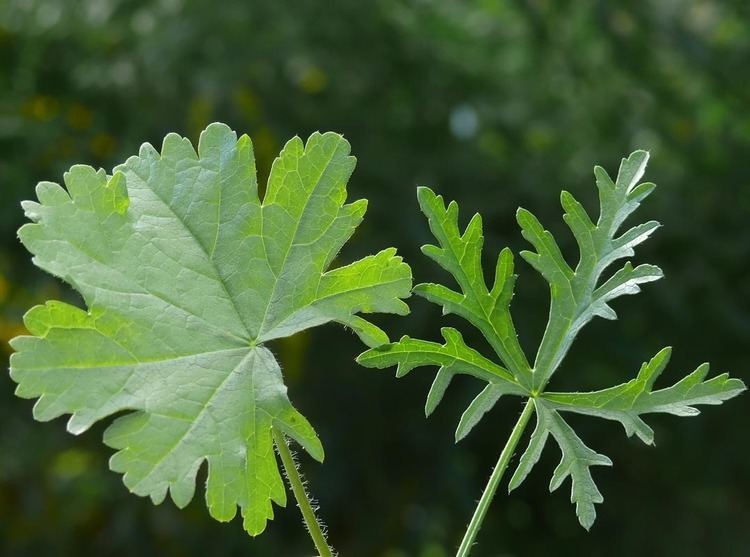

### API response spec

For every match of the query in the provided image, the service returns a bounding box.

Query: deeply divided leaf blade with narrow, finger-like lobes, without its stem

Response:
[358,151,745,529]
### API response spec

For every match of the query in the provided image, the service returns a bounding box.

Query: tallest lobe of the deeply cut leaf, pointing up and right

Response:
[517,151,662,392]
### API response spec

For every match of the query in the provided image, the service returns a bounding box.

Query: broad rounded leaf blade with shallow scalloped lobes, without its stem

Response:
[11,124,411,535]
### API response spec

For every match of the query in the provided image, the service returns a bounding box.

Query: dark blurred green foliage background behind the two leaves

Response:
[0,0,750,557]
